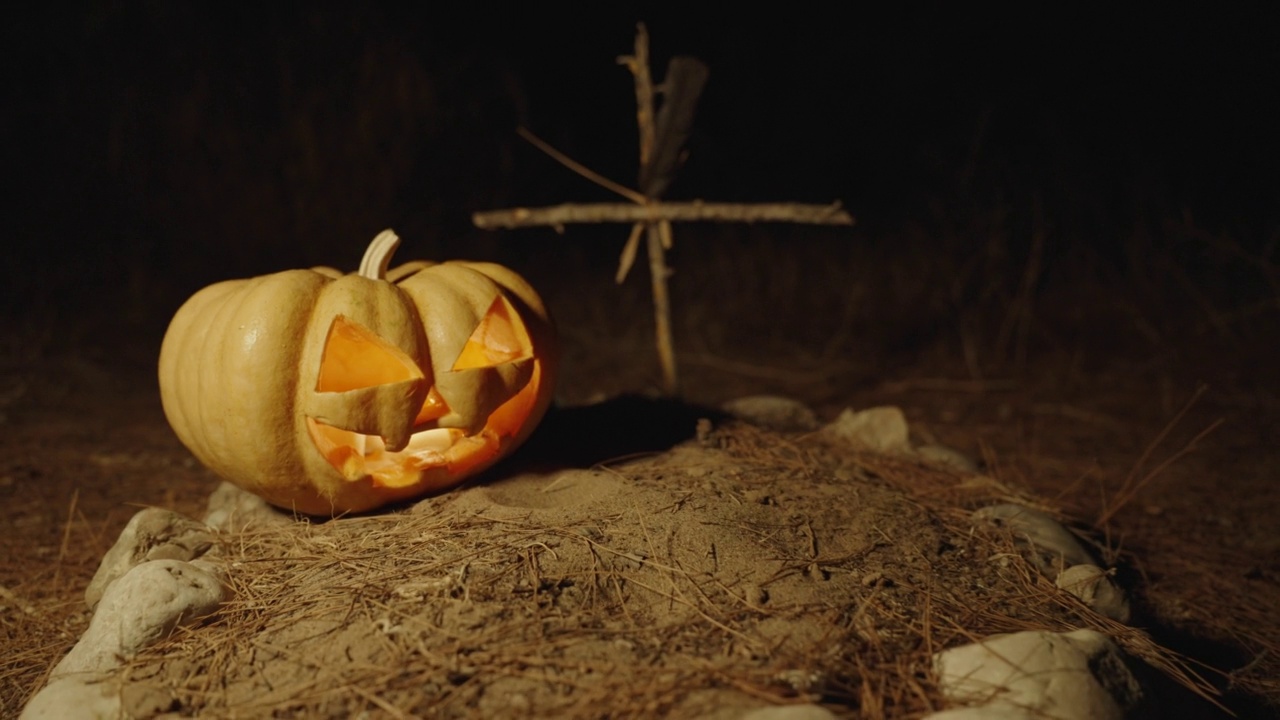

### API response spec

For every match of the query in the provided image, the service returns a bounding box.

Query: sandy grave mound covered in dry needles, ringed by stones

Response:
[97,424,1216,717]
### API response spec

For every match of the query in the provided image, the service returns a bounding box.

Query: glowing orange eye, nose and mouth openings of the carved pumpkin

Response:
[307,296,540,488]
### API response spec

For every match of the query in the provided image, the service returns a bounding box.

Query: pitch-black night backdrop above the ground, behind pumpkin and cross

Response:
[3,1,1280,363]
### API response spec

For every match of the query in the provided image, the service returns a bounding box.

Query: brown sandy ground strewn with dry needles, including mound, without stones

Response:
[0,326,1280,717]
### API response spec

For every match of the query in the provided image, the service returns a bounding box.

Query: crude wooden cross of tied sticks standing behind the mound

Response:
[471,23,854,396]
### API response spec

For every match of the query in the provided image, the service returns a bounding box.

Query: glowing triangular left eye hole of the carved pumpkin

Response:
[316,315,422,392]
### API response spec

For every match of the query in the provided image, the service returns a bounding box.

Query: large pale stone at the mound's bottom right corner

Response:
[929,630,1142,720]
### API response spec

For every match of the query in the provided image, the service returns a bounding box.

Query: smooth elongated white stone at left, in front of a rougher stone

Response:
[53,560,225,676]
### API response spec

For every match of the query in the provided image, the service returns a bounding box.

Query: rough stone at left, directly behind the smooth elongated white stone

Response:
[84,507,214,610]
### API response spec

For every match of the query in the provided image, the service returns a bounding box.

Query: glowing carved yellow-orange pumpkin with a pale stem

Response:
[160,231,557,515]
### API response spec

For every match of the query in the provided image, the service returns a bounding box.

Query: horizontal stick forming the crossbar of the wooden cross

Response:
[471,200,854,229]
